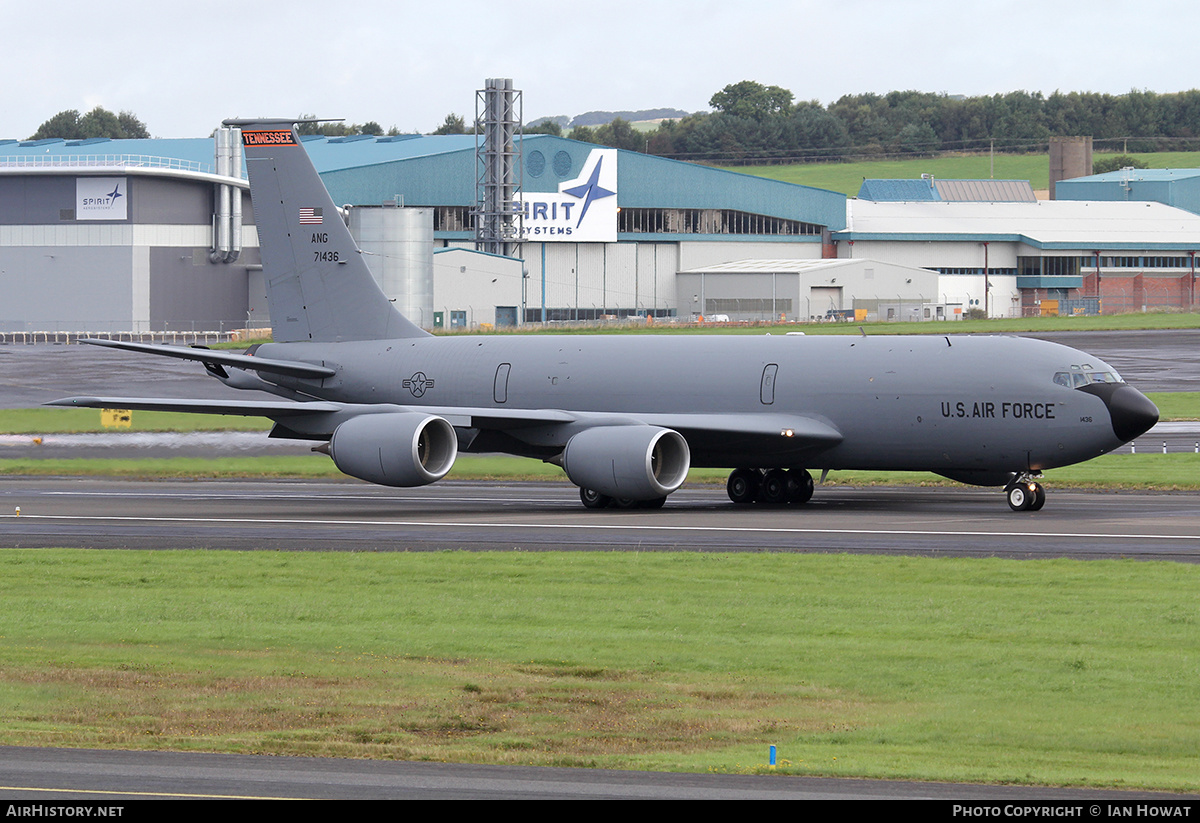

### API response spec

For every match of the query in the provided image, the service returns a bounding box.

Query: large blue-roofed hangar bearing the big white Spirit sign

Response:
[306,134,846,322]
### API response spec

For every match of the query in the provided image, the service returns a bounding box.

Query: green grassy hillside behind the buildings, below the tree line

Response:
[725,151,1200,197]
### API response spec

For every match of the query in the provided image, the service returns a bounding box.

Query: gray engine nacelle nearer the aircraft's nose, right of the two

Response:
[563,426,691,500]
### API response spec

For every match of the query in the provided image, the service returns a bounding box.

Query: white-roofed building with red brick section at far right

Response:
[849,180,1200,317]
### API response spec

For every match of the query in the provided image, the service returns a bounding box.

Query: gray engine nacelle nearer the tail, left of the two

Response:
[329,412,458,486]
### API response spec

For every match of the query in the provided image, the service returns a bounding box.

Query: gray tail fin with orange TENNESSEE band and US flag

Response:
[224,120,426,343]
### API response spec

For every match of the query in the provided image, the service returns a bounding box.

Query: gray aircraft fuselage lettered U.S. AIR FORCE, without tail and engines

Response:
[258,335,1148,481]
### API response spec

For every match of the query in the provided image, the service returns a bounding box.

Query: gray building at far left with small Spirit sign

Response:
[0,133,258,334]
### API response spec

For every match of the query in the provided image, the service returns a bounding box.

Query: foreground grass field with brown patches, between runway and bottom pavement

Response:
[0,549,1200,792]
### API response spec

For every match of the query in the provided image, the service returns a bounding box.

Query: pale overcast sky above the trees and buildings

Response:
[0,0,1200,140]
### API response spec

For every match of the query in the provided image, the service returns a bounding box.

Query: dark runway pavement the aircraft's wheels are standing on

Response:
[0,477,1200,563]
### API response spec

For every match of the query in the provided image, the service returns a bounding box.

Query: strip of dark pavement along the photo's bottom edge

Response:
[0,746,1194,801]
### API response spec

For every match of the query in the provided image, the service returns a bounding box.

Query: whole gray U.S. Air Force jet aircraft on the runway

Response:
[50,120,1158,511]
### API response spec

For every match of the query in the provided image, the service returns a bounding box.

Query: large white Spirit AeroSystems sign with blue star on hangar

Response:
[518,149,617,242]
